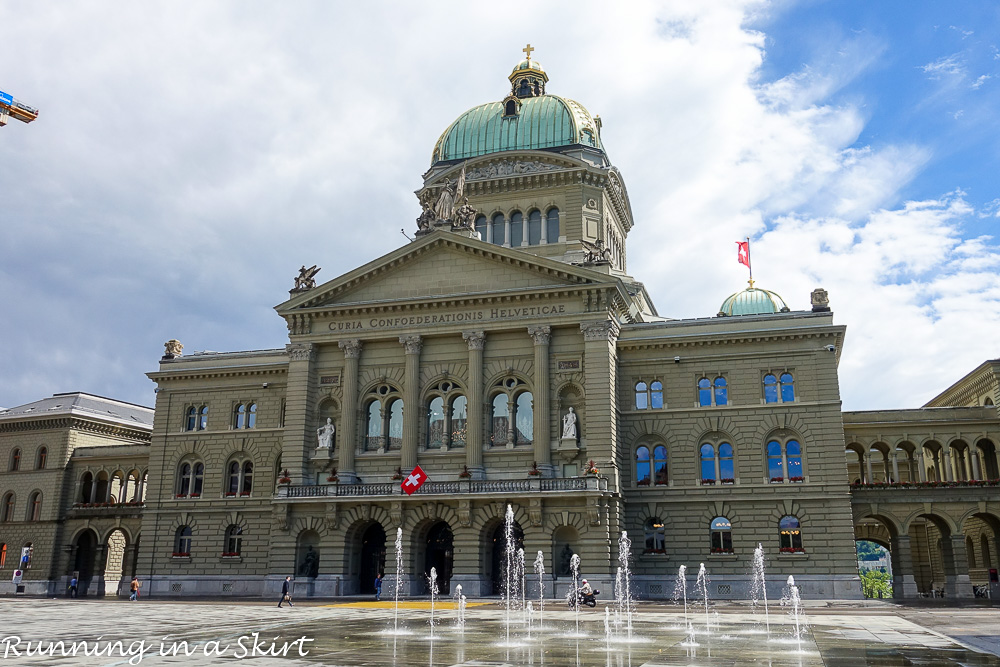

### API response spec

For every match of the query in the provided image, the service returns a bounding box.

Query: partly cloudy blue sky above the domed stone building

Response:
[0,0,1000,409]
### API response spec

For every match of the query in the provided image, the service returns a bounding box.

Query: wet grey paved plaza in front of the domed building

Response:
[0,598,1000,667]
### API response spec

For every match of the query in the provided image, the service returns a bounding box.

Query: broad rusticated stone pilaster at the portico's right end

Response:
[580,320,621,492]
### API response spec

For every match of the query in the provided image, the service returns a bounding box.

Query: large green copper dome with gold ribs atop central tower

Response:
[431,95,601,162]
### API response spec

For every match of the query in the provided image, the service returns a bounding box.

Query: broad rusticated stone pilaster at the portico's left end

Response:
[281,343,316,484]
